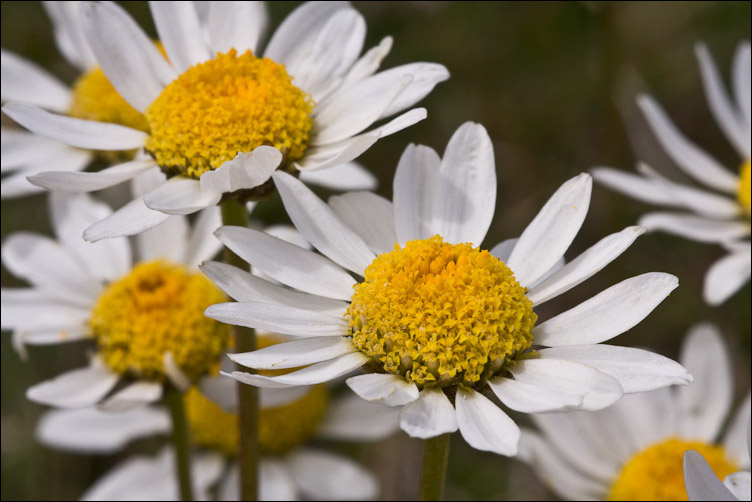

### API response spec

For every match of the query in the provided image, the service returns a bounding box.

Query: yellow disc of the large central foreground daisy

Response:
[347,235,537,388]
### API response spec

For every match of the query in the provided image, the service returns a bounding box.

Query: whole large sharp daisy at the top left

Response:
[3,2,449,241]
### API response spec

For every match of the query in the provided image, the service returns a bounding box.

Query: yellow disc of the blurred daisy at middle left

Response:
[89,261,230,381]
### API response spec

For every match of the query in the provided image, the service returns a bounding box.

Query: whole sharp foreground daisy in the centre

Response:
[202,123,690,455]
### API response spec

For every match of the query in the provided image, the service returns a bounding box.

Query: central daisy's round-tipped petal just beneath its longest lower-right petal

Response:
[510,359,624,411]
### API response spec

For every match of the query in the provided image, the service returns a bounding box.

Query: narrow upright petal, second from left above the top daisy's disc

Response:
[149,2,210,73]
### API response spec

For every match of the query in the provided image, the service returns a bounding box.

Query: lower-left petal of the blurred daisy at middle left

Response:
[26,363,120,408]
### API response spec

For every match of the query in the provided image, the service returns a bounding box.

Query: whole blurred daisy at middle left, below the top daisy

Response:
[2,189,230,409]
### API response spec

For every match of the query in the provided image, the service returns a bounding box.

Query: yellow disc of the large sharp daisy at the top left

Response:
[146,49,313,178]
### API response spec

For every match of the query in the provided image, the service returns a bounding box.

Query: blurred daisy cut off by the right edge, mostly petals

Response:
[592,42,752,305]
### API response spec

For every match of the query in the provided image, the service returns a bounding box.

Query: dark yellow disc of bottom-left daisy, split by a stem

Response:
[184,385,329,456]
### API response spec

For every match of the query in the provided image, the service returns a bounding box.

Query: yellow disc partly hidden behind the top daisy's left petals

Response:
[68,66,149,132]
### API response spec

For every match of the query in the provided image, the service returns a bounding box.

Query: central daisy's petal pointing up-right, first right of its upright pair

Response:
[507,173,593,286]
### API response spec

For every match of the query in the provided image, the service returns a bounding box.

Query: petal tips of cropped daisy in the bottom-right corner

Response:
[684,422,752,500]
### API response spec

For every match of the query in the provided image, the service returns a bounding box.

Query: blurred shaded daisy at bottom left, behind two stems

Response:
[37,352,398,500]
